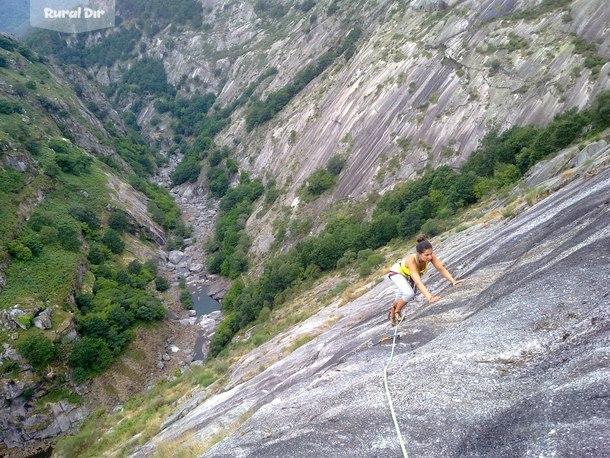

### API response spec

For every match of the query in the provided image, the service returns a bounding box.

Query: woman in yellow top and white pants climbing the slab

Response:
[388,236,463,326]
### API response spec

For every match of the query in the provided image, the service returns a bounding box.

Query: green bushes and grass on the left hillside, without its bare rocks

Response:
[0,37,173,380]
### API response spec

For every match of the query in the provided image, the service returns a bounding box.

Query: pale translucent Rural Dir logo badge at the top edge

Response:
[30,0,115,33]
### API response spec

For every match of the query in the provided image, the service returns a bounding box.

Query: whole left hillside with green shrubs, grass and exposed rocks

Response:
[0,35,187,456]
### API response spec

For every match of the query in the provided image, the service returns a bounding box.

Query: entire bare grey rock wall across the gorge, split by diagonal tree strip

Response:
[85,0,610,254]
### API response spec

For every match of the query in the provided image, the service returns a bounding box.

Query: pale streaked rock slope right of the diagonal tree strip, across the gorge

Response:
[238,0,610,253]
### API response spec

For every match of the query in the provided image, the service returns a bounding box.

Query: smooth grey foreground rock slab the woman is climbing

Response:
[134,169,610,457]
